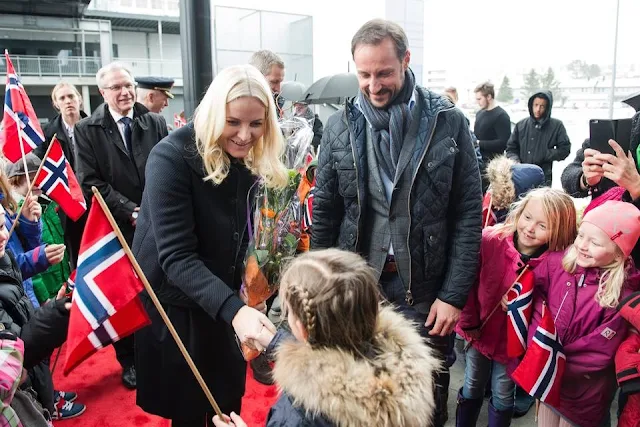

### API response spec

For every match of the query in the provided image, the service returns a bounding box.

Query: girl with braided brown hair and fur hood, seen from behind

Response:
[214,249,440,427]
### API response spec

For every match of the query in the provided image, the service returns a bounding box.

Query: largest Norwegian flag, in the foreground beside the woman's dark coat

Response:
[64,197,150,374]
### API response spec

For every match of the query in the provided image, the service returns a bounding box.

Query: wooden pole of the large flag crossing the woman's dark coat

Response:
[91,187,226,420]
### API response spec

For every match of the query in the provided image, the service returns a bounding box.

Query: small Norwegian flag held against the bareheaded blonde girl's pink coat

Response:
[507,268,533,357]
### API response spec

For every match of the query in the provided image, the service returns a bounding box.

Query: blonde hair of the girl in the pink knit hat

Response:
[562,245,627,308]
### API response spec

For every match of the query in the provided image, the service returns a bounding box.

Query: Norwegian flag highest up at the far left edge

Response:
[0,50,44,163]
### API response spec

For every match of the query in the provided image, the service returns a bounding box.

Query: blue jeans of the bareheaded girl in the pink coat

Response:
[462,347,515,411]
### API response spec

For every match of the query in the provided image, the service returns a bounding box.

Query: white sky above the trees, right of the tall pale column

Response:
[425,0,640,72]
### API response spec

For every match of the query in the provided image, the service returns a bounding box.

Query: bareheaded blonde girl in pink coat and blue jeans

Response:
[456,187,576,427]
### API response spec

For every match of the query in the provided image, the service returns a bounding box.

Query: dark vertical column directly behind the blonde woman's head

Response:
[180,0,213,118]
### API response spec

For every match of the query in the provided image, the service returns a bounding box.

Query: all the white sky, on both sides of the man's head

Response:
[212,0,640,87]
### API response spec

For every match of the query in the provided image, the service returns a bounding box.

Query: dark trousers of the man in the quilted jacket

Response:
[380,273,455,427]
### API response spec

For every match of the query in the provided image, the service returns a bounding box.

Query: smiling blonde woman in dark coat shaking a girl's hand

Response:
[133,65,287,427]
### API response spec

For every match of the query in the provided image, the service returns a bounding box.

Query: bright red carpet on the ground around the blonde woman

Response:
[52,346,277,427]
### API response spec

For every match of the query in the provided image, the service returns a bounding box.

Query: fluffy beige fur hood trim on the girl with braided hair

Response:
[273,307,440,427]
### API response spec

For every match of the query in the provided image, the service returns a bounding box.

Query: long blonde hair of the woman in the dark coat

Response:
[193,65,288,187]
